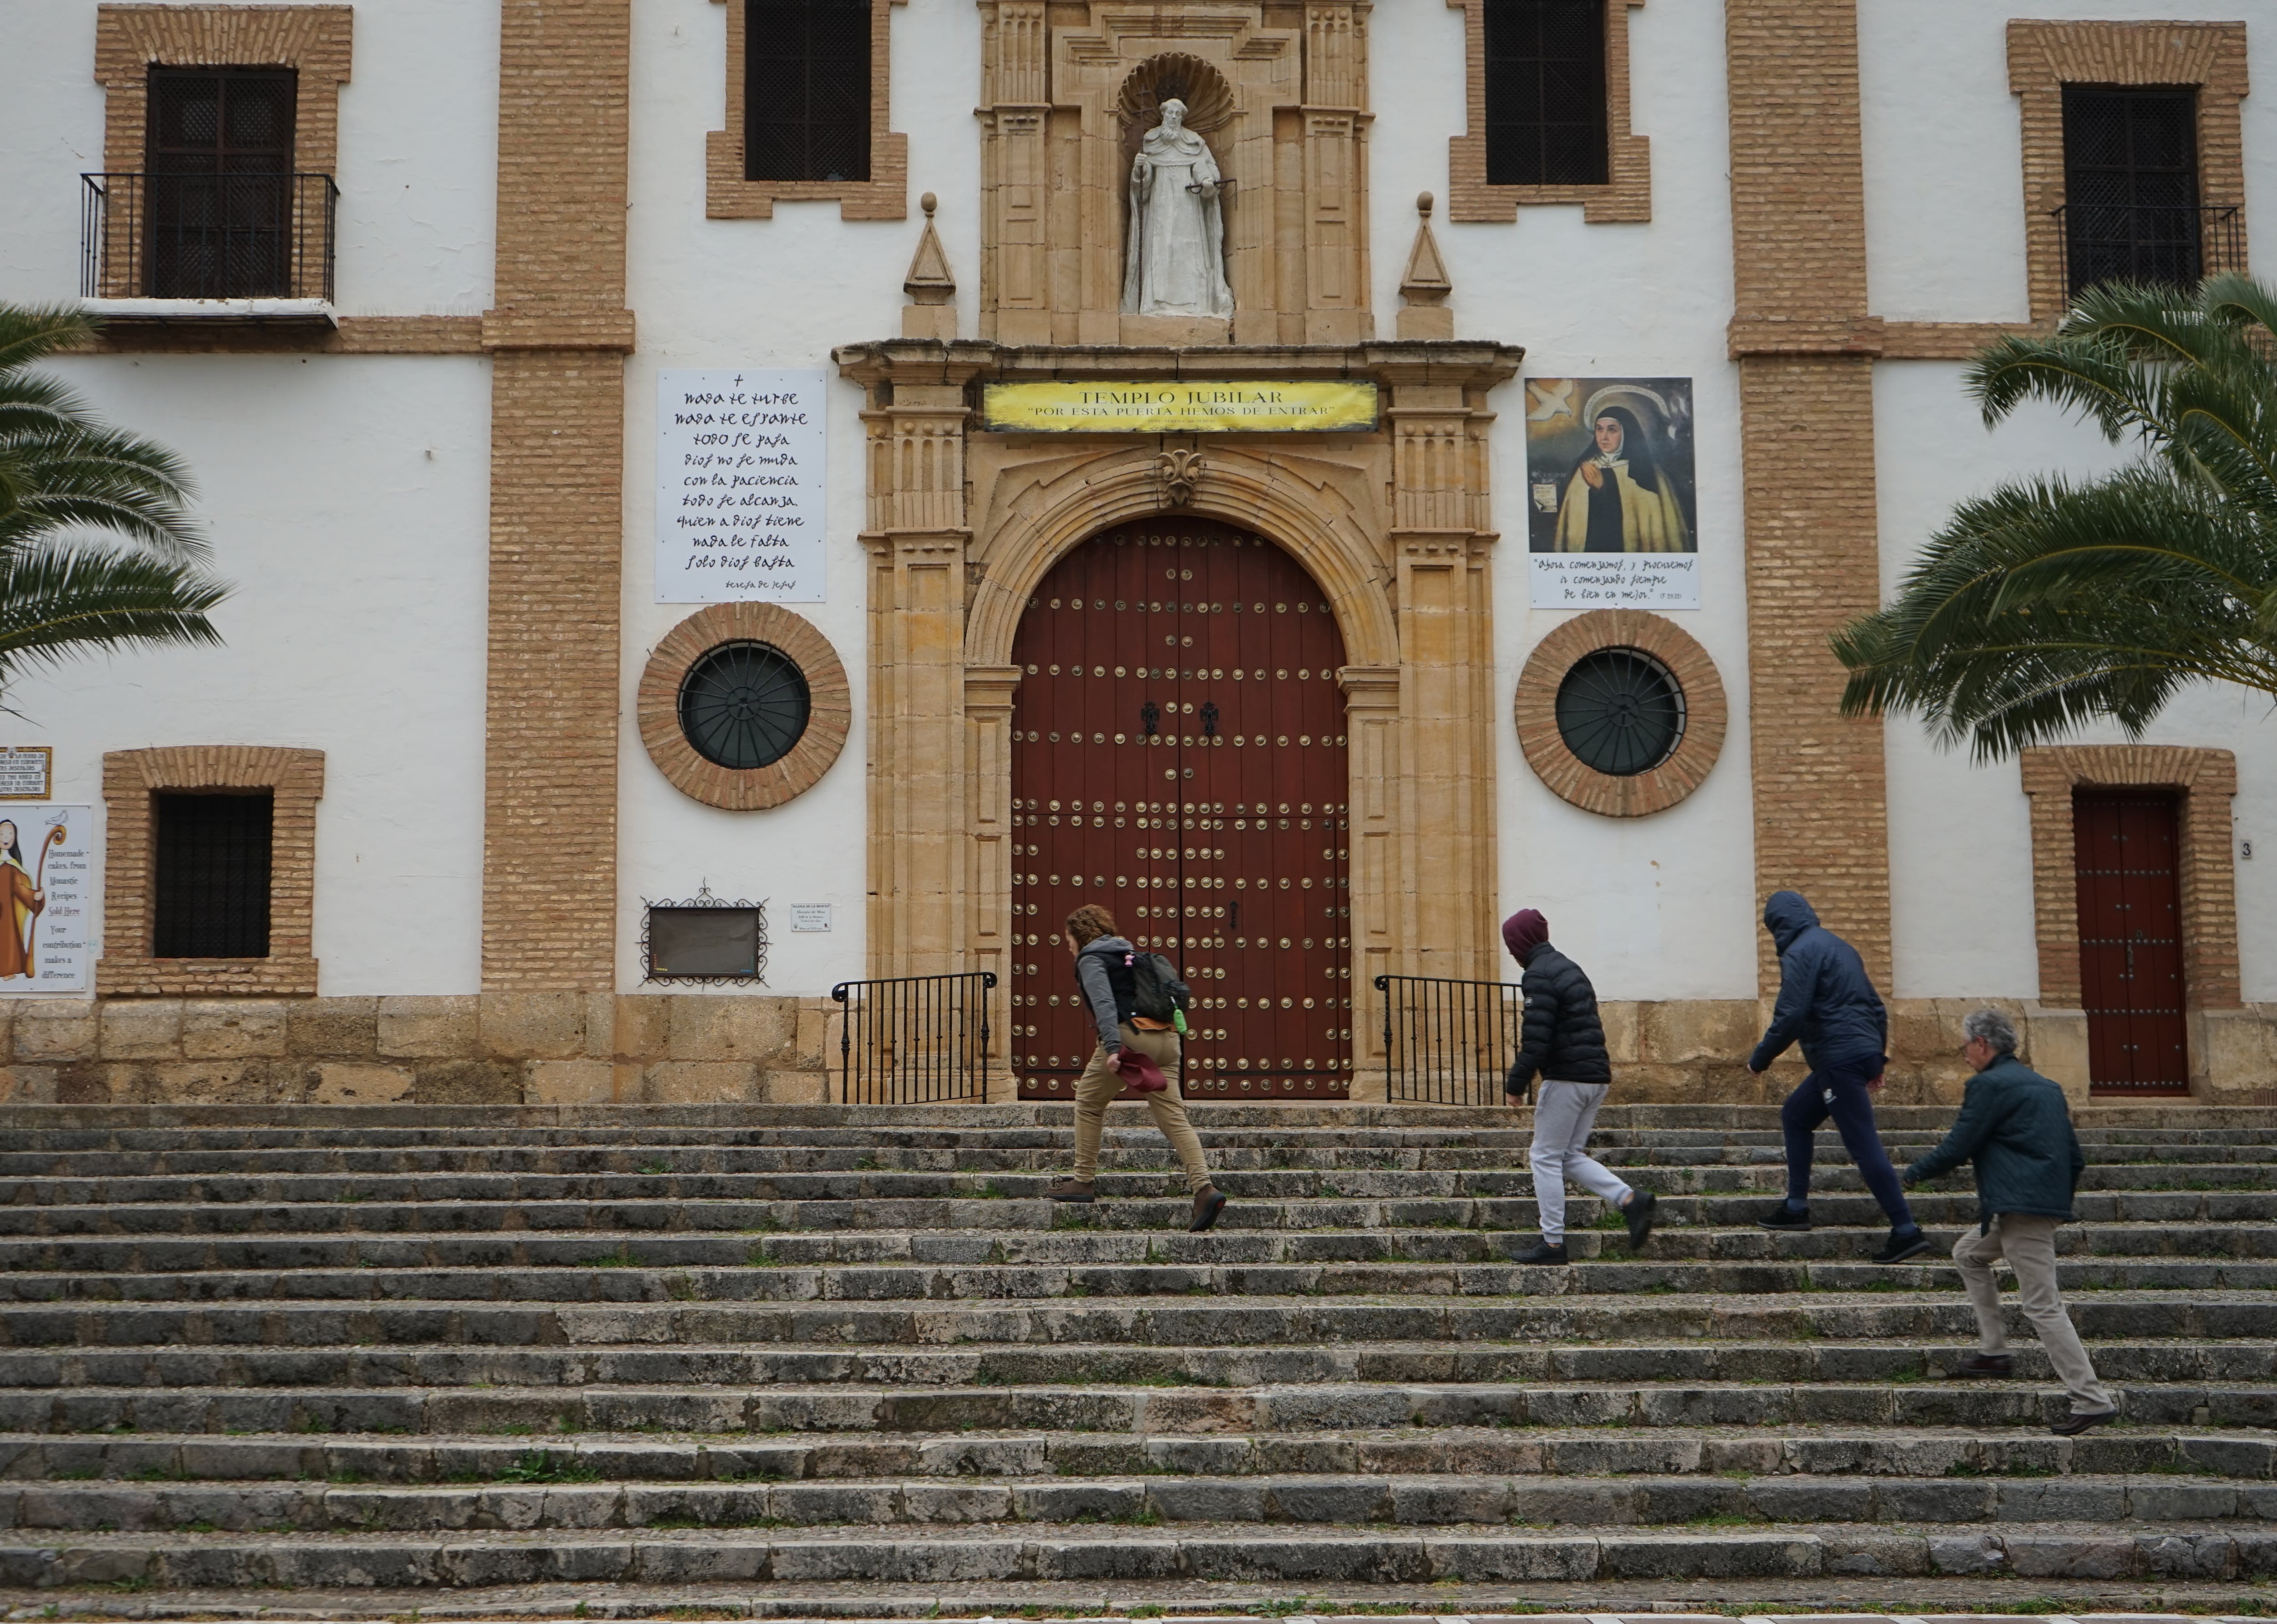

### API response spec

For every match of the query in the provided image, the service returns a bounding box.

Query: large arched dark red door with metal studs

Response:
[1009,517,1355,1100]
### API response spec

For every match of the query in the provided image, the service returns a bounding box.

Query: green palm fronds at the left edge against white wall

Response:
[0,305,228,710]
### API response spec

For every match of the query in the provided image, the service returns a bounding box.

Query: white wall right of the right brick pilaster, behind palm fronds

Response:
[1858,0,2277,1000]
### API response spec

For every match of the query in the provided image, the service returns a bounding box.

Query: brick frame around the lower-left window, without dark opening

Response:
[96,745,323,998]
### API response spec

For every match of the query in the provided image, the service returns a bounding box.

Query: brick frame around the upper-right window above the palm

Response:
[2008,20,2247,326]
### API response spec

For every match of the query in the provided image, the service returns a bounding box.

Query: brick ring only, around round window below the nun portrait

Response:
[1512,608,1731,818]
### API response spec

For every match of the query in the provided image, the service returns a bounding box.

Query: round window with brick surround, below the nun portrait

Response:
[1514,608,1731,818]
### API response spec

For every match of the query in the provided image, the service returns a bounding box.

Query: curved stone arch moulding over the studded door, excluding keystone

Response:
[965,444,1400,667]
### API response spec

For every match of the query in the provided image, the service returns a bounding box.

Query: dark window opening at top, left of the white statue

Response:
[742,0,870,180]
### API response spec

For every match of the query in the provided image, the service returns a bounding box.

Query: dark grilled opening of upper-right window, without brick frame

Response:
[2063,84,2204,294]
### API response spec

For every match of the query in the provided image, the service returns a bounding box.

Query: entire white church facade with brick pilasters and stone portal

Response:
[0,0,2277,1109]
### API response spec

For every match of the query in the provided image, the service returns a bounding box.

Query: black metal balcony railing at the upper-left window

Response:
[80,173,339,300]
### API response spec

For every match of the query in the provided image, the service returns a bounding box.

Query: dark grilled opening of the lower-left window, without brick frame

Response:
[150,790,276,959]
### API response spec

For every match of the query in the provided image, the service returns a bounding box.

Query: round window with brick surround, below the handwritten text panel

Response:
[635,604,854,811]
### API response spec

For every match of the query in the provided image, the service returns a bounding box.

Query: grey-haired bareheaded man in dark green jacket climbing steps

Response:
[1906,1009,2120,1437]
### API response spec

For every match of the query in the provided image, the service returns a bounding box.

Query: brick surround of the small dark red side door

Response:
[2022,745,2241,1009]
